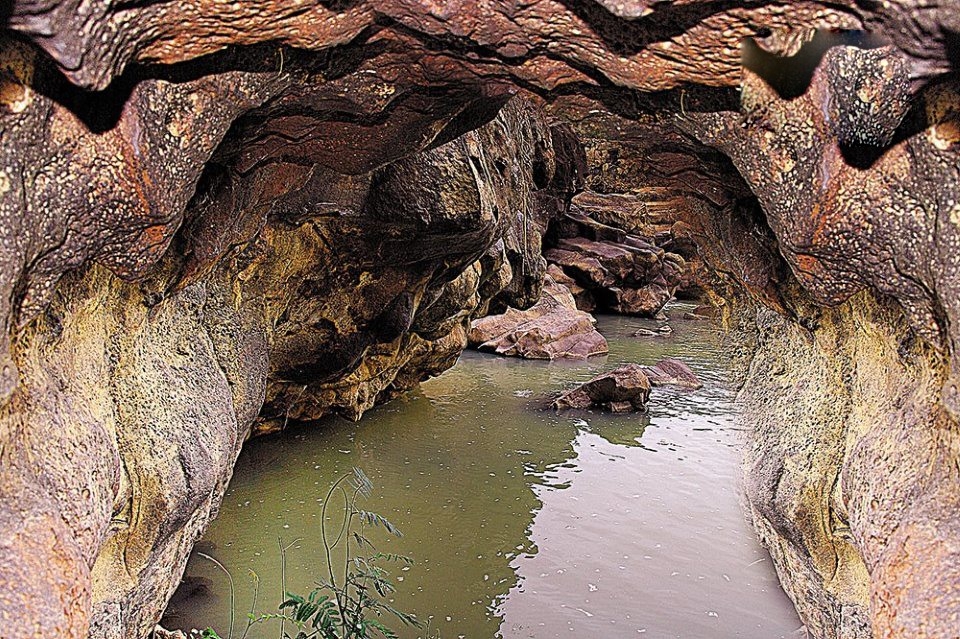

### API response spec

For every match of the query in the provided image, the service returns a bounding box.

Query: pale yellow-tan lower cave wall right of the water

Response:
[741,292,960,639]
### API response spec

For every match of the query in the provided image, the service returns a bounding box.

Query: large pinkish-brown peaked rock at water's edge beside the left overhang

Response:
[468,275,607,360]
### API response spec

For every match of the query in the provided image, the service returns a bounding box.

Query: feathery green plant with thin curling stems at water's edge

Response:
[191,468,422,639]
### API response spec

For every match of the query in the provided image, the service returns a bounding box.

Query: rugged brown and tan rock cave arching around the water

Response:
[0,0,960,639]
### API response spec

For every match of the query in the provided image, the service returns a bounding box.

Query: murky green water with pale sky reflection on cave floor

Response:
[164,309,800,639]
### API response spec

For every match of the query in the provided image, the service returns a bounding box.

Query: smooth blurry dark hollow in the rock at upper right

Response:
[741,29,889,100]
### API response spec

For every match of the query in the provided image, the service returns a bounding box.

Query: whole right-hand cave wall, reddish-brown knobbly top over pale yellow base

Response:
[690,37,960,637]
